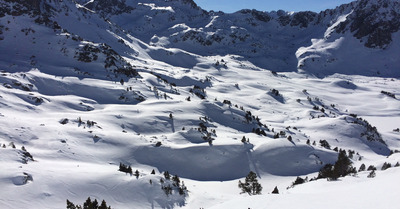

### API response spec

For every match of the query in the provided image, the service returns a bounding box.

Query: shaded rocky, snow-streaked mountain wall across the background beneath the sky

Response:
[85,0,400,76]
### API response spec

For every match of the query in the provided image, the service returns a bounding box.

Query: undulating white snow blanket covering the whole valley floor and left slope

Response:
[0,1,400,209]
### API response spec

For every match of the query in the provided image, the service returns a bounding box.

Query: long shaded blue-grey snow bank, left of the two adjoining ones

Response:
[132,145,250,181]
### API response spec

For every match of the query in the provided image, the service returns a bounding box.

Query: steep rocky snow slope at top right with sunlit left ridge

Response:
[296,0,400,77]
